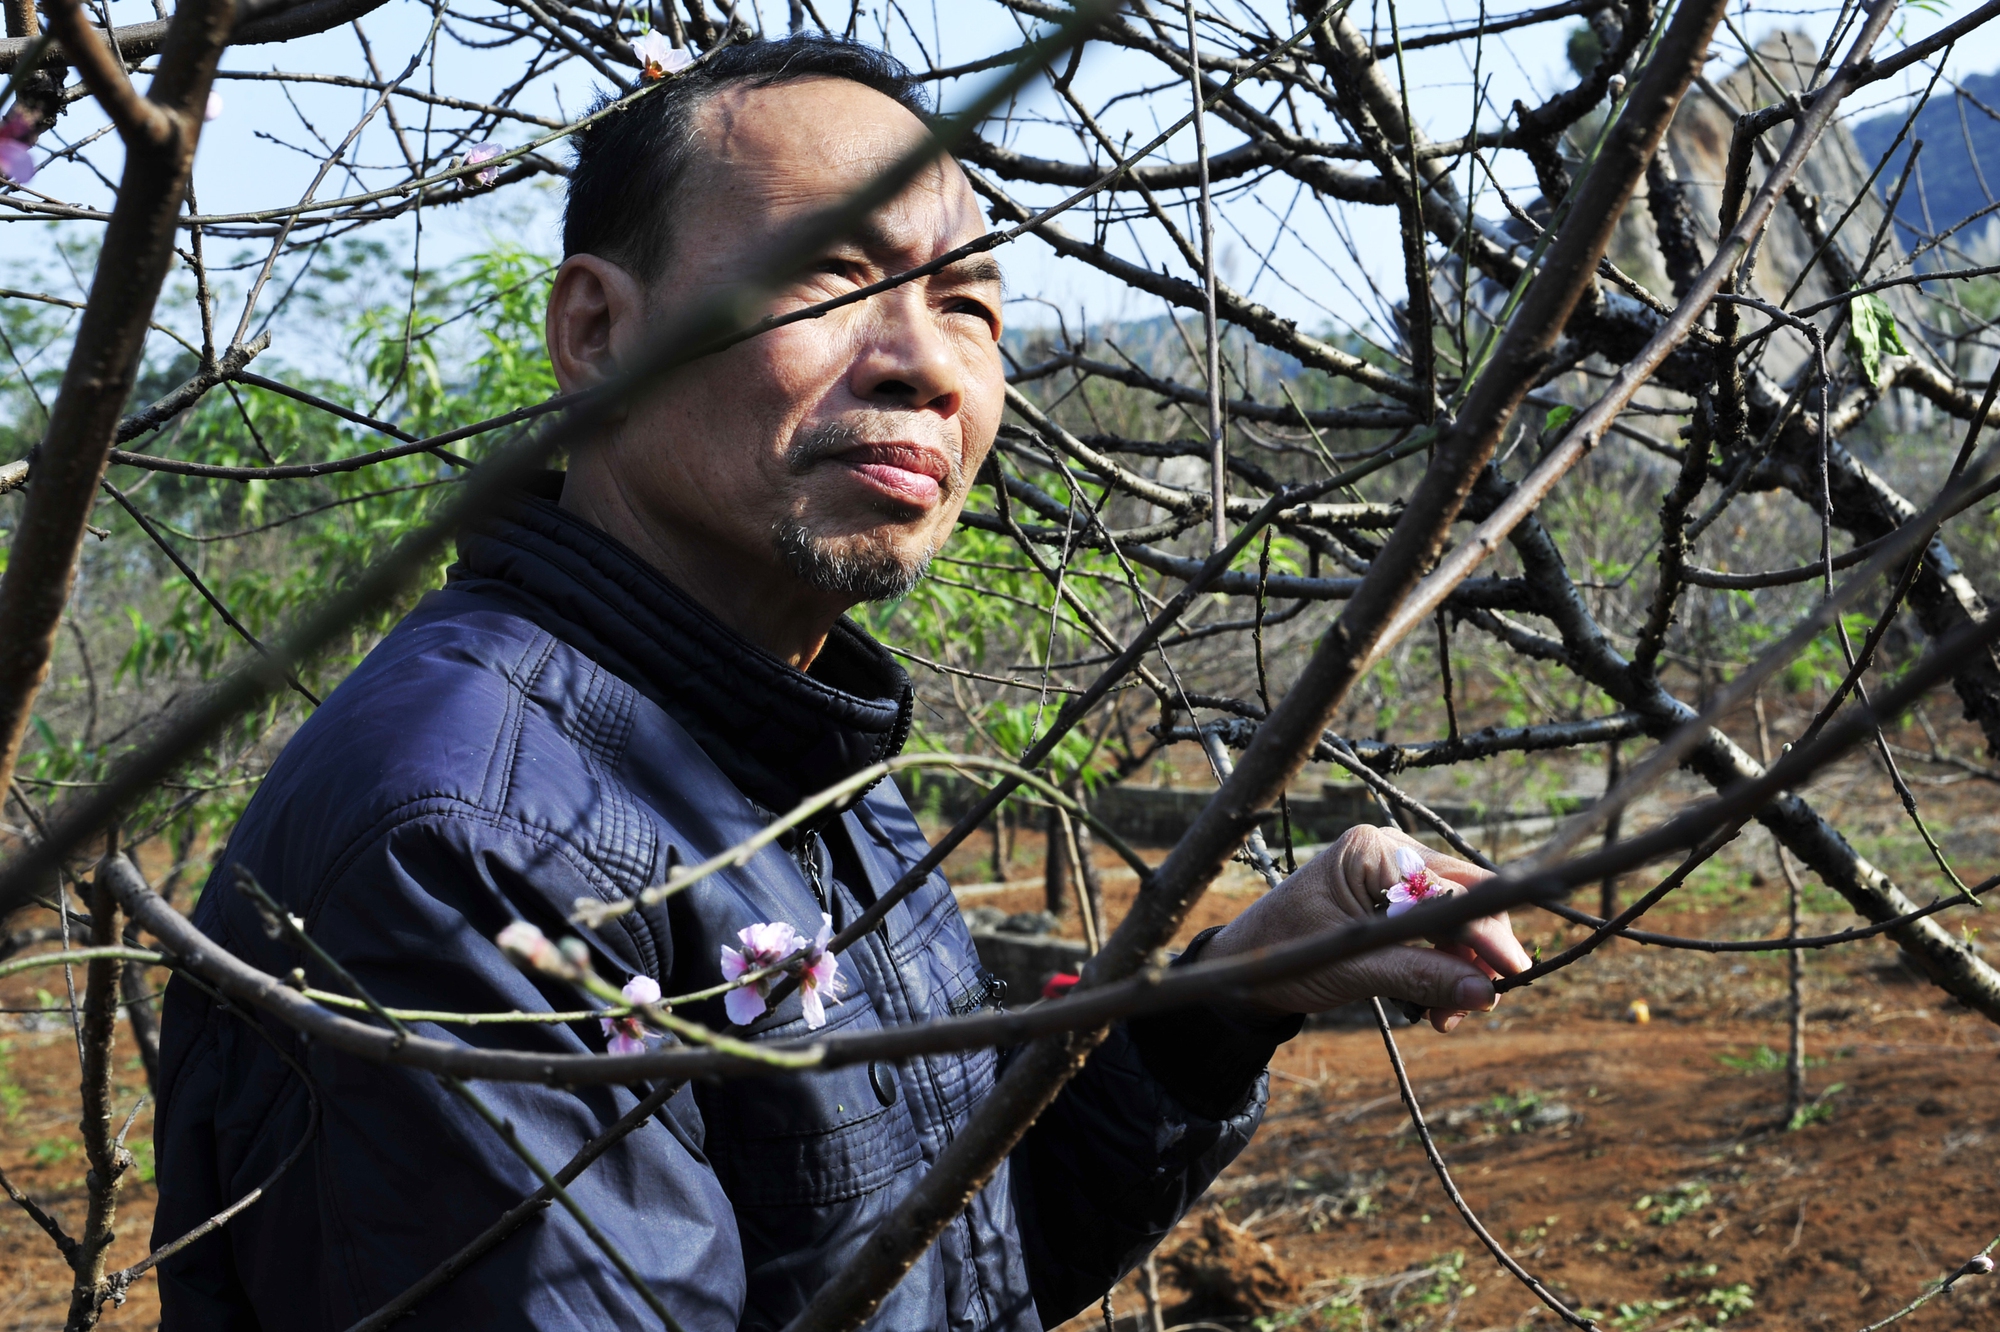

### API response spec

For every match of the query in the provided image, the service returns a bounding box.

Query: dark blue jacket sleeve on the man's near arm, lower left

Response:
[154,814,744,1332]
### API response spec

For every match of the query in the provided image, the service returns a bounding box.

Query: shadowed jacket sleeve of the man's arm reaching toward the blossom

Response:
[1008,930,1304,1328]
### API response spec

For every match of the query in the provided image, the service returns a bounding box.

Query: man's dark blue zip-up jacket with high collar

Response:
[154,480,1296,1332]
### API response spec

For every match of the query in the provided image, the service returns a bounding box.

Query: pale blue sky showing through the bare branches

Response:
[0,0,1992,360]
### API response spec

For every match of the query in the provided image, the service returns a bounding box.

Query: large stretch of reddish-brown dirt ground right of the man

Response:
[1068,920,2000,1332]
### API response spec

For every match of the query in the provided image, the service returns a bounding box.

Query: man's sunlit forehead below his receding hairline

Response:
[690,78,986,262]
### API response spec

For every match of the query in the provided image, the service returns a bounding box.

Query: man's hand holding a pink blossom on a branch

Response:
[1202,828,1530,1032]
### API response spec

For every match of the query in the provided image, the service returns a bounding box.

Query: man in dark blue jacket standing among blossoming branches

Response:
[154,40,1526,1332]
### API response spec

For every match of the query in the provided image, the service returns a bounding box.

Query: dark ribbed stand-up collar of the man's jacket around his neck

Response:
[446,472,910,812]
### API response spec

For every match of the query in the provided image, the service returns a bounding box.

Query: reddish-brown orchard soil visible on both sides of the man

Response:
[0,712,2000,1332]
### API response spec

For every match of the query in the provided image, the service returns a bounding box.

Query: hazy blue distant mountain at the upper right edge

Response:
[1852,70,2000,246]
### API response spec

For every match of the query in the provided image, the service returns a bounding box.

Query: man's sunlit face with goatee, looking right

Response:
[560,78,1004,610]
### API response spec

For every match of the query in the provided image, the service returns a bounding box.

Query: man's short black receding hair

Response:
[562,34,930,282]
